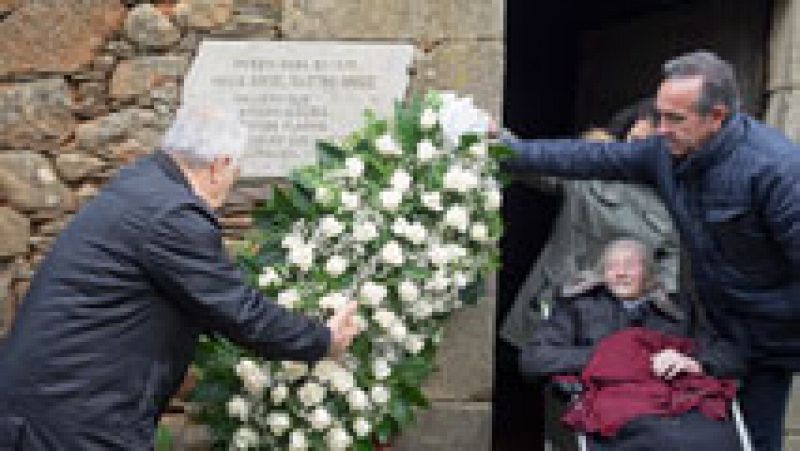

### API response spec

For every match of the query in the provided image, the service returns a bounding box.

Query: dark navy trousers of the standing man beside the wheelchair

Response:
[739,367,792,451]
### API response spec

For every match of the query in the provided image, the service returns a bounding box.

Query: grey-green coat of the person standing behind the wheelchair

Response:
[500,177,680,349]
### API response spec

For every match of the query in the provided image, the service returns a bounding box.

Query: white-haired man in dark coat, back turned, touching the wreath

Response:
[0,104,355,451]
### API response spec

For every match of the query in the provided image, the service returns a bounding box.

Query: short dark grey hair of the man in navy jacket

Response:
[663,50,741,115]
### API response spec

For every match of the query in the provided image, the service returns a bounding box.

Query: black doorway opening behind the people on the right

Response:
[493,0,772,451]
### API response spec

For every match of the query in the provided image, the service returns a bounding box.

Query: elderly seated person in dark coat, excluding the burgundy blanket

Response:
[519,240,743,450]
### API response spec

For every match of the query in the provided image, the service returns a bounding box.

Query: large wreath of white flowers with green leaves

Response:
[225,94,501,450]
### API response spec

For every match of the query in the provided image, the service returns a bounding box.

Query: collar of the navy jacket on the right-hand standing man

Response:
[675,113,745,177]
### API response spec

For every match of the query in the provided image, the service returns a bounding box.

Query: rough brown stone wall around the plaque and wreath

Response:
[0,0,504,450]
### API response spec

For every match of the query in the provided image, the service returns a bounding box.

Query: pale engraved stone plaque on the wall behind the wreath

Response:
[183,41,413,178]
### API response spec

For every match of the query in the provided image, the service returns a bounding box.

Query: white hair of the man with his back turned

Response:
[161,103,247,166]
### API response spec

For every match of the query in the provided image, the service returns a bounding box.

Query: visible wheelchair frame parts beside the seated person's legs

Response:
[544,381,753,451]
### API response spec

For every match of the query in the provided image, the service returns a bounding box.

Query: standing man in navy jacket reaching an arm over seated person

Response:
[506,51,800,450]
